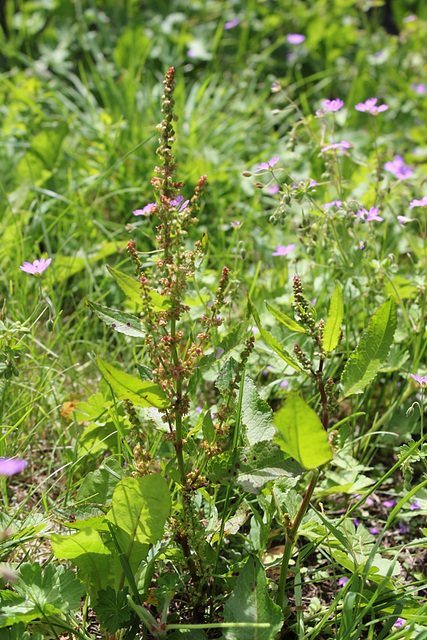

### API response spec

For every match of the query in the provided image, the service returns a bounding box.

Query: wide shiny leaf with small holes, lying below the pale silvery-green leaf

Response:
[208,440,304,493]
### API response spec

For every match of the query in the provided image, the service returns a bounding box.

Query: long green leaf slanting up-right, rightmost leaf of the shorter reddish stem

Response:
[341,298,397,398]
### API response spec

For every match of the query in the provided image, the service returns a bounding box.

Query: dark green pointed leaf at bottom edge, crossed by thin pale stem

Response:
[224,557,283,640]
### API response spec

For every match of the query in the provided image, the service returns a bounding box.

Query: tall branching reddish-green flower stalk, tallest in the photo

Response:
[127,67,229,581]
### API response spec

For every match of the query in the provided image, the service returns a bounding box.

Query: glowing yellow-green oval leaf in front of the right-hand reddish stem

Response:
[273,393,332,469]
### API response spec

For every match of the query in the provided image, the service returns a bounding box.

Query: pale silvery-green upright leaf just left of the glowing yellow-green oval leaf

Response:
[242,376,274,445]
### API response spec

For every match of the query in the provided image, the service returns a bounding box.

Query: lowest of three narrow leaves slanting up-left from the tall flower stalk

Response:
[96,356,170,409]
